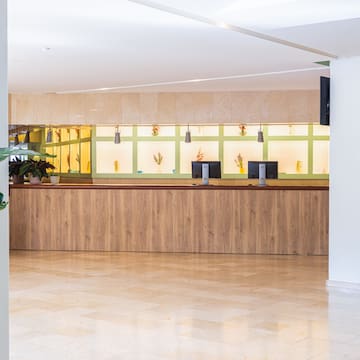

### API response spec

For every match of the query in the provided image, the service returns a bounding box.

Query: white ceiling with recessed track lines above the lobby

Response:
[8,0,360,92]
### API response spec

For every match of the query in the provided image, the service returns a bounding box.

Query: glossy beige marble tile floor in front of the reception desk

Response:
[10,251,360,360]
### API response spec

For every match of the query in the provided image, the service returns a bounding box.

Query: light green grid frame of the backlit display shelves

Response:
[41,124,330,179]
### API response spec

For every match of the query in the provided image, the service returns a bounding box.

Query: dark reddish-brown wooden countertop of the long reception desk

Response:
[10,183,329,191]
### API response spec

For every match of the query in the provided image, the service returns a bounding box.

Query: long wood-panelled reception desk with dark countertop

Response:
[10,184,329,255]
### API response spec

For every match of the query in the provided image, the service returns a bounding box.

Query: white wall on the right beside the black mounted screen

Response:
[329,57,360,285]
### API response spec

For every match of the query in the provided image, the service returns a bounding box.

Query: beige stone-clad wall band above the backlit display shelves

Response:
[9,90,319,125]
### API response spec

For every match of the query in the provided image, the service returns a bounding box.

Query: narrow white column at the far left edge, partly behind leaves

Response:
[0,0,9,360]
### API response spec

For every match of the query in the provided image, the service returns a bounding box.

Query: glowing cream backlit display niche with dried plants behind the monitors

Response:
[93,124,329,179]
